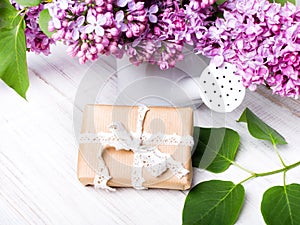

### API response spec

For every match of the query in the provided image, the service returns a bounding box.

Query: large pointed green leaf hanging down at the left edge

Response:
[0,16,29,99]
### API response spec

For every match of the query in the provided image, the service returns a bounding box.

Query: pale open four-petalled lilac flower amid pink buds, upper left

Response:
[84,14,106,37]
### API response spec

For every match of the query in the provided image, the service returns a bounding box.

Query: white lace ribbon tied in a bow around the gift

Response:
[79,106,194,191]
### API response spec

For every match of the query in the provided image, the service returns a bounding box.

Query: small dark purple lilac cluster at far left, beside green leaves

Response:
[11,1,54,55]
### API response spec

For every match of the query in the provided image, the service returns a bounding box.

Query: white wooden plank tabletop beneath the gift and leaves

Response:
[0,42,300,225]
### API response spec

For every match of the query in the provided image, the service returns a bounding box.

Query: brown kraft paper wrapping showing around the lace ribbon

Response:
[78,105,193,190]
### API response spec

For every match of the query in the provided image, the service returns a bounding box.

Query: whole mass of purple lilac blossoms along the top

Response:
[13,0,300,98]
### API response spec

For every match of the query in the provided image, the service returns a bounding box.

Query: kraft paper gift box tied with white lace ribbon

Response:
[78,105,193,190]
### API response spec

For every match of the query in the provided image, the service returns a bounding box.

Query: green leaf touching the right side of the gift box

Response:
[192,127,240,173]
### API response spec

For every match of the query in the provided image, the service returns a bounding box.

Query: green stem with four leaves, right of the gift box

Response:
[188,108,300,225]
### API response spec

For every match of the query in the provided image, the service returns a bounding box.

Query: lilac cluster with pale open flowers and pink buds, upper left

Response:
[46,0,122,64]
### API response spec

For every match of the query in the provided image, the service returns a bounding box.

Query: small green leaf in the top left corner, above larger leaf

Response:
[0,0,18,29]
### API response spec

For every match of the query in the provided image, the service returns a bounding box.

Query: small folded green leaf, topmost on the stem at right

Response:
[238,108,287,145]
